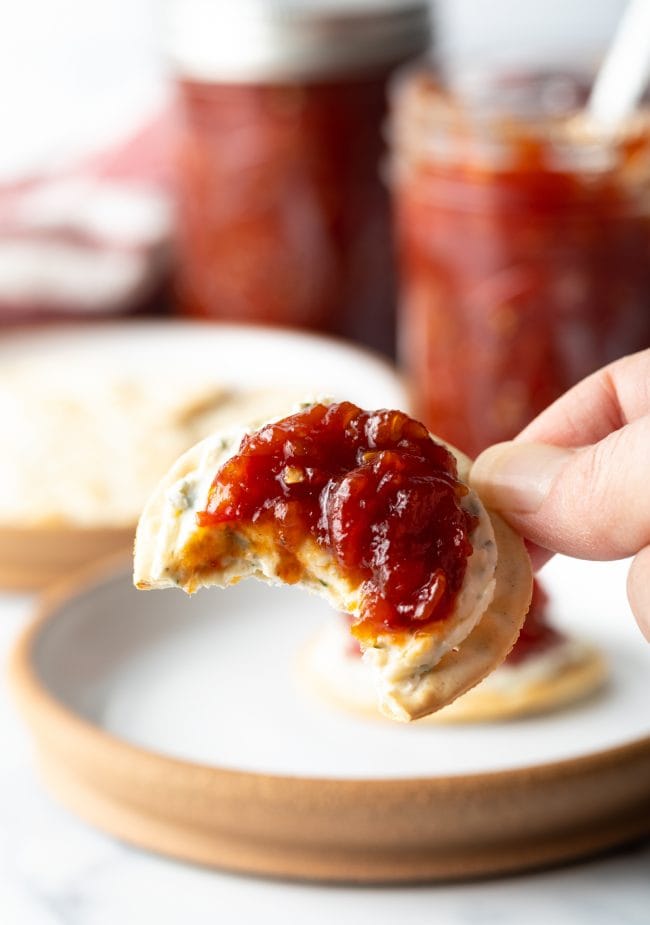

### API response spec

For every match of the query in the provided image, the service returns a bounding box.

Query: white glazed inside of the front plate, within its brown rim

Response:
[27,558,650,778]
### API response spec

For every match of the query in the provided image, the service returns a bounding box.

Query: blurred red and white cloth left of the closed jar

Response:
[0,115,171,322]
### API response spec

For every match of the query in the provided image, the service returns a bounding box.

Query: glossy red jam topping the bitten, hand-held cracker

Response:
[198,402,476,638]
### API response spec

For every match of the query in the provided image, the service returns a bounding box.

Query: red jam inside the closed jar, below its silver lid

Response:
[175,76,396,353]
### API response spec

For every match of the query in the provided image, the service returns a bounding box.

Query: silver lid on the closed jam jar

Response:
[166,0,431,82]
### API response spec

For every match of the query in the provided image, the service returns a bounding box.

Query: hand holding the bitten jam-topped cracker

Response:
[470,350,650,641]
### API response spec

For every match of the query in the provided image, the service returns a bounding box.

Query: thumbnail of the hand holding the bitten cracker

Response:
[470,442,574,514]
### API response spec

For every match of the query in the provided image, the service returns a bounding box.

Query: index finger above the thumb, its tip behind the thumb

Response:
[515,349,650,447]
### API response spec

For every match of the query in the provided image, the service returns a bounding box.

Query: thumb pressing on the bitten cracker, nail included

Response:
[470,416,650,559]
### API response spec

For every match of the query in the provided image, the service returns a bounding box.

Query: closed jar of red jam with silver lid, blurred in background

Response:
[170,0,429,352]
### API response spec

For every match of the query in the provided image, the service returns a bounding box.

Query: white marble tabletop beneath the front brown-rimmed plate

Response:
[0,595,650,925]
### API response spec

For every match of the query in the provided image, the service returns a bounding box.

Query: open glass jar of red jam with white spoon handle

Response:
[391,68,650,455]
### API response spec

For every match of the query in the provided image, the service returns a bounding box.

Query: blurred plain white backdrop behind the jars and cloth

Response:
[0,0,625,181]
